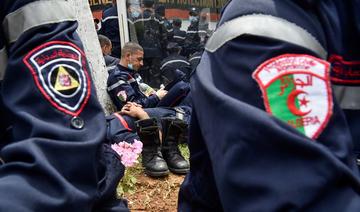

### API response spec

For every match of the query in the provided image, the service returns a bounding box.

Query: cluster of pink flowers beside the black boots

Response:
[111,139,143,167]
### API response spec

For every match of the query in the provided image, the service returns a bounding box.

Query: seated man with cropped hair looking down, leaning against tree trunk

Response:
[107,42,190,110]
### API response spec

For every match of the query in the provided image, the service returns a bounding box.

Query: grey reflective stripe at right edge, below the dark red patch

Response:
[333,85,360,110]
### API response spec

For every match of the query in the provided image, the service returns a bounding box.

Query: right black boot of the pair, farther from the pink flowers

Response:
[161,119,190,174]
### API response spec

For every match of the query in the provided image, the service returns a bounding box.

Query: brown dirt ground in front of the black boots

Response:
[125,173,185,212]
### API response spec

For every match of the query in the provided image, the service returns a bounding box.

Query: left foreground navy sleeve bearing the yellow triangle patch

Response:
[0,0,106,211]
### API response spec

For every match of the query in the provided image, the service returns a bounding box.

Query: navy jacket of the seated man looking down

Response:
[107,64,160,110]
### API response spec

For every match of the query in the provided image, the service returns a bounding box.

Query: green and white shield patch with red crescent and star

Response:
[253,54,333,139]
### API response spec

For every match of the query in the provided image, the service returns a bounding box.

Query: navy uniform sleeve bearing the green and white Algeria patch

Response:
[179,1,360,211]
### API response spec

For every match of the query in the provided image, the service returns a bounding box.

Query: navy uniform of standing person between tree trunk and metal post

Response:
[99,5,121,58]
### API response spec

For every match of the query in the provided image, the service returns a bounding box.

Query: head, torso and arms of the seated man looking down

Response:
[107,42,167,110]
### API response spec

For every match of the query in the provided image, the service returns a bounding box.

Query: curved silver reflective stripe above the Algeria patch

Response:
[205,14,327,59]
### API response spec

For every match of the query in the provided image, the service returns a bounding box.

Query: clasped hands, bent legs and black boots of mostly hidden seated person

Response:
[116,102,191,177]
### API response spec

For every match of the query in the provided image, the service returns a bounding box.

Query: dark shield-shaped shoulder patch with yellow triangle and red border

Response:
[23,41,91,116]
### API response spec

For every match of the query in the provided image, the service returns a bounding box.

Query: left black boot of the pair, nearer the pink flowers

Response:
[136,119,169,177]
